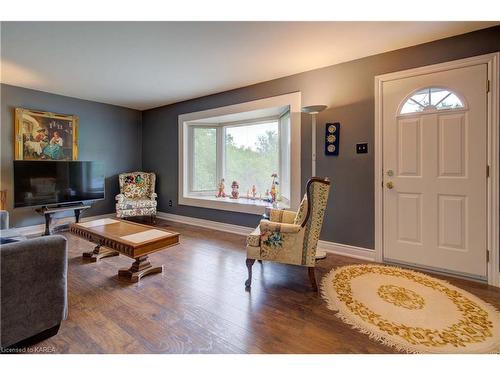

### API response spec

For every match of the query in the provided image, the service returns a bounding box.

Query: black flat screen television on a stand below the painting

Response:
[14,160,104,207]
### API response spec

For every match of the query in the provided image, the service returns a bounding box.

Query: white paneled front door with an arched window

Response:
[382,64,488,278]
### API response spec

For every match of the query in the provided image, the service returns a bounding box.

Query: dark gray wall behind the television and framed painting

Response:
[0,84,142,226]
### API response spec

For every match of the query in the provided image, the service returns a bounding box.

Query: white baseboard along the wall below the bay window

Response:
[157,212,375,261]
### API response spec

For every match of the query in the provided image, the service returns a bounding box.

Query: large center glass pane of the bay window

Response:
[224,120,280,198]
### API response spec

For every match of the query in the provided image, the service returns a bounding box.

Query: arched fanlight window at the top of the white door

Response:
[399,87,465,115]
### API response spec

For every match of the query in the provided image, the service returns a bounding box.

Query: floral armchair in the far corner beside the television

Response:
[116,172,157,222]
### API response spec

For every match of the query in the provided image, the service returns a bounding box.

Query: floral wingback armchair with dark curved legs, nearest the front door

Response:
[245,177,330,290]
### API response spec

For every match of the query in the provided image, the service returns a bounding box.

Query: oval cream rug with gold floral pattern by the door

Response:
[321,264,500,353]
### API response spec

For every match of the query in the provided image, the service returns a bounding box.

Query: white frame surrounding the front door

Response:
[374,52,500,287]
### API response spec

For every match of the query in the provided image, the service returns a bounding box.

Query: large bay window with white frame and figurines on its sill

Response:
[179,94,300,213]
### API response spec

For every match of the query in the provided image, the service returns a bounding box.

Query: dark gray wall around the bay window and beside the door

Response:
[142,27,500,248]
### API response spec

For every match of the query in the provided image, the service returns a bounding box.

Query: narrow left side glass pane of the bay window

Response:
[191,128,217,191]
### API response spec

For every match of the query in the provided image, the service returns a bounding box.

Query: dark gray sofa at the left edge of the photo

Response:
[0,215,68,348]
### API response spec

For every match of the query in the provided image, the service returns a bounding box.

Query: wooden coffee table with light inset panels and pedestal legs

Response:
[70,219,179,283]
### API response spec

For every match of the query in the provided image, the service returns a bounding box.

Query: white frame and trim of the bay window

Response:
[178,92,301,214]
